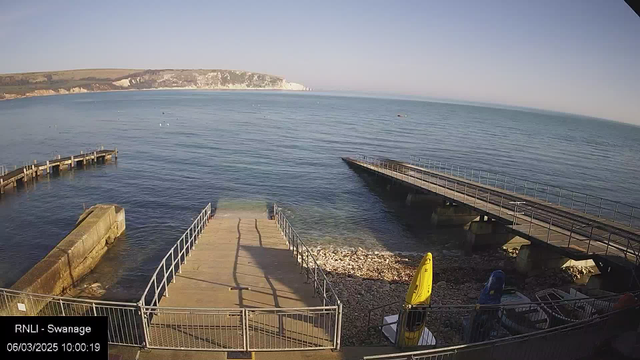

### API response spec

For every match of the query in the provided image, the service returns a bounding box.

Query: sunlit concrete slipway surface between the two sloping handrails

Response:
[160,217,322,308]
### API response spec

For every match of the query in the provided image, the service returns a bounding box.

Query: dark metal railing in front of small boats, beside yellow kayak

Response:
[367,294,632,347]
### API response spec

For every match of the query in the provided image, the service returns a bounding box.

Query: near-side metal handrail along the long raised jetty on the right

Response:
[360,156,640,265]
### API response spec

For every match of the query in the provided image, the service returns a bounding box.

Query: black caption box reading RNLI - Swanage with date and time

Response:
[0,316,109,360]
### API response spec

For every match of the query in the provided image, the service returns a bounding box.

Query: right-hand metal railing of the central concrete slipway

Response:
[273,204,342,349]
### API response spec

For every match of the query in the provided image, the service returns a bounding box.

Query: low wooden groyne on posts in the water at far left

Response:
[0,148,118,194]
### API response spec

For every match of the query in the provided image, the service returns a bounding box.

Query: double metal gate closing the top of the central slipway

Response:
[143,306,339,351]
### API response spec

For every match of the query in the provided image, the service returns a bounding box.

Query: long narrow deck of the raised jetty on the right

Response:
[343,157,640,268]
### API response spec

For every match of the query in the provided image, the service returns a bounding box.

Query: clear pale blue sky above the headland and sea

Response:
[0,0,640,124]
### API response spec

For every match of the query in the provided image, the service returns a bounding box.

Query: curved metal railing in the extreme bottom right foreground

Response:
[363,305,639,360]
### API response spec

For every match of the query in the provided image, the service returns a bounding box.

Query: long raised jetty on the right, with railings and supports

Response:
[343,156,640,272]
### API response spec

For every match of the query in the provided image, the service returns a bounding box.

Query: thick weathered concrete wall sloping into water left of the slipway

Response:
[4,204,126,312]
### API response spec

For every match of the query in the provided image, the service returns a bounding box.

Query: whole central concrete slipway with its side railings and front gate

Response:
[141,204,342,351]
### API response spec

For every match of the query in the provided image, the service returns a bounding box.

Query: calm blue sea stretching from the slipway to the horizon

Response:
[0,91,640,298]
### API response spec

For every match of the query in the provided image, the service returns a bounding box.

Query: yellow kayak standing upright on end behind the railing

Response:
[398,253,433,347]
